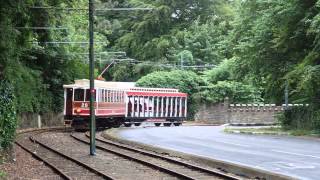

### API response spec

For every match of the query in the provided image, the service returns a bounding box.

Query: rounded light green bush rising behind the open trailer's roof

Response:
[136,70,202,119]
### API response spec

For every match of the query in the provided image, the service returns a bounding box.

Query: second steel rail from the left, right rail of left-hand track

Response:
[30,136,115,180]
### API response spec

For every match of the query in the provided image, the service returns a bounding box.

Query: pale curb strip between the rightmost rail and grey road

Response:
[102,128,295,180]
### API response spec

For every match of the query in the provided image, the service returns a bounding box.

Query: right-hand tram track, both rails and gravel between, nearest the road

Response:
[71,133,243,180]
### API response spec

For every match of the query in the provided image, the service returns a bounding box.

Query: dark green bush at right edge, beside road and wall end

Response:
[278,106,320,132]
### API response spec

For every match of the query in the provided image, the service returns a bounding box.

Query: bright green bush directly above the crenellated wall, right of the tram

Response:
[200,59,263,103]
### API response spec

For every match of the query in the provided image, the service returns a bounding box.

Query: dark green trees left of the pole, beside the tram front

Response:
[0,0,105,112]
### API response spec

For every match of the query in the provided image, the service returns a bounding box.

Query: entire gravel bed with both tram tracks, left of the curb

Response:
[16,128,240,179]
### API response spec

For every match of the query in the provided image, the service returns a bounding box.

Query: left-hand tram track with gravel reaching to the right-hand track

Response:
[21,131,182,179]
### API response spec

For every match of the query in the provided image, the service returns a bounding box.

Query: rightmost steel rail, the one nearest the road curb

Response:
[90,133,240,180]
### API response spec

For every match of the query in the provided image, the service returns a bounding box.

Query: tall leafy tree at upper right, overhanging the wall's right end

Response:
[230,0,319,103]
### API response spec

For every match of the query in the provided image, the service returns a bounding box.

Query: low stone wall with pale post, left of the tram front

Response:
[18,113,64,129]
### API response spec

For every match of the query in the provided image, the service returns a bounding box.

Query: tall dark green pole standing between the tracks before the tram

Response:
[89,0,96,156]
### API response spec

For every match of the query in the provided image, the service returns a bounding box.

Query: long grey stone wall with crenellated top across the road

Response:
[195,102,308,124]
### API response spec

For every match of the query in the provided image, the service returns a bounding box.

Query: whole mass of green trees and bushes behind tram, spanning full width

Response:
[0,0,320,130]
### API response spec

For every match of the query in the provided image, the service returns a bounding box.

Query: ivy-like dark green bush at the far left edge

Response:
[0,80,17,150]
